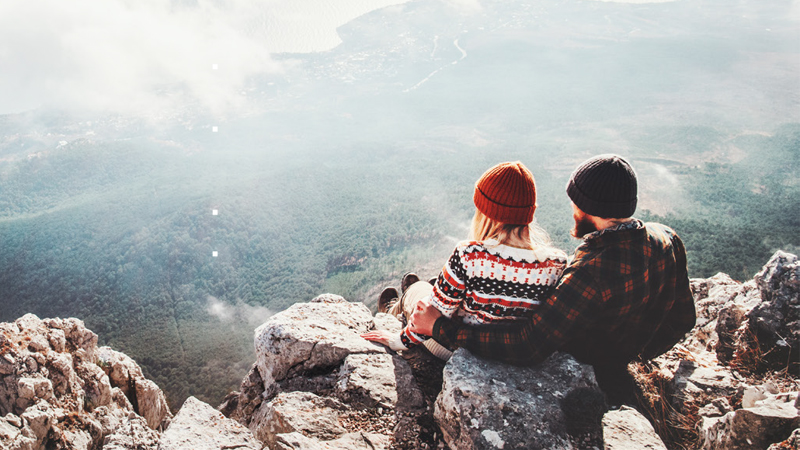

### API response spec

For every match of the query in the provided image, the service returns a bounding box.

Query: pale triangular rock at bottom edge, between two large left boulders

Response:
[158,397,263,450]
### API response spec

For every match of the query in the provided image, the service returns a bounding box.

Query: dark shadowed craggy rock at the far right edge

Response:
[747,251,800,373]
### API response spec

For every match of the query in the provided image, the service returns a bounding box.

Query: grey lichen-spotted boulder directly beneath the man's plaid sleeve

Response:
[434,349,605,450]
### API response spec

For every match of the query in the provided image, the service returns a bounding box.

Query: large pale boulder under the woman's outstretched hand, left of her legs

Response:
[220,294,424,450]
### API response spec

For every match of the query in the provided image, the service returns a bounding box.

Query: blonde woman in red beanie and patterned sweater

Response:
[362,161,567,359]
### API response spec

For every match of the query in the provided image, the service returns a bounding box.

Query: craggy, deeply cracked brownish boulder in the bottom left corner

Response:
[0,314,171,450]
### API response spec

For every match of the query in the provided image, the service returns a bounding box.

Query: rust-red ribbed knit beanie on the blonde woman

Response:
[472,161,536,225]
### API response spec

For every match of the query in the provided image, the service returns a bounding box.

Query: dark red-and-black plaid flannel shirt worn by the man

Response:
[433,220,696,366]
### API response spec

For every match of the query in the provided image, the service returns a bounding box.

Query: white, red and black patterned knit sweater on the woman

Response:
[400,239,567,348]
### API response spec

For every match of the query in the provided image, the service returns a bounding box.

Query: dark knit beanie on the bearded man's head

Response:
[567,155,637,219]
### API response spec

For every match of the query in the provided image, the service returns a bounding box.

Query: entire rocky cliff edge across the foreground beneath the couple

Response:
[0,252,800,450]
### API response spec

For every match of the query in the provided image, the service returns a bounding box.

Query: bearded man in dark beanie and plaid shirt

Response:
[410,155,696,404]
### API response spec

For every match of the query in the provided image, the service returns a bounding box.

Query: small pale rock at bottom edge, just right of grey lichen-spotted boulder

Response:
[603,406,667,450]
